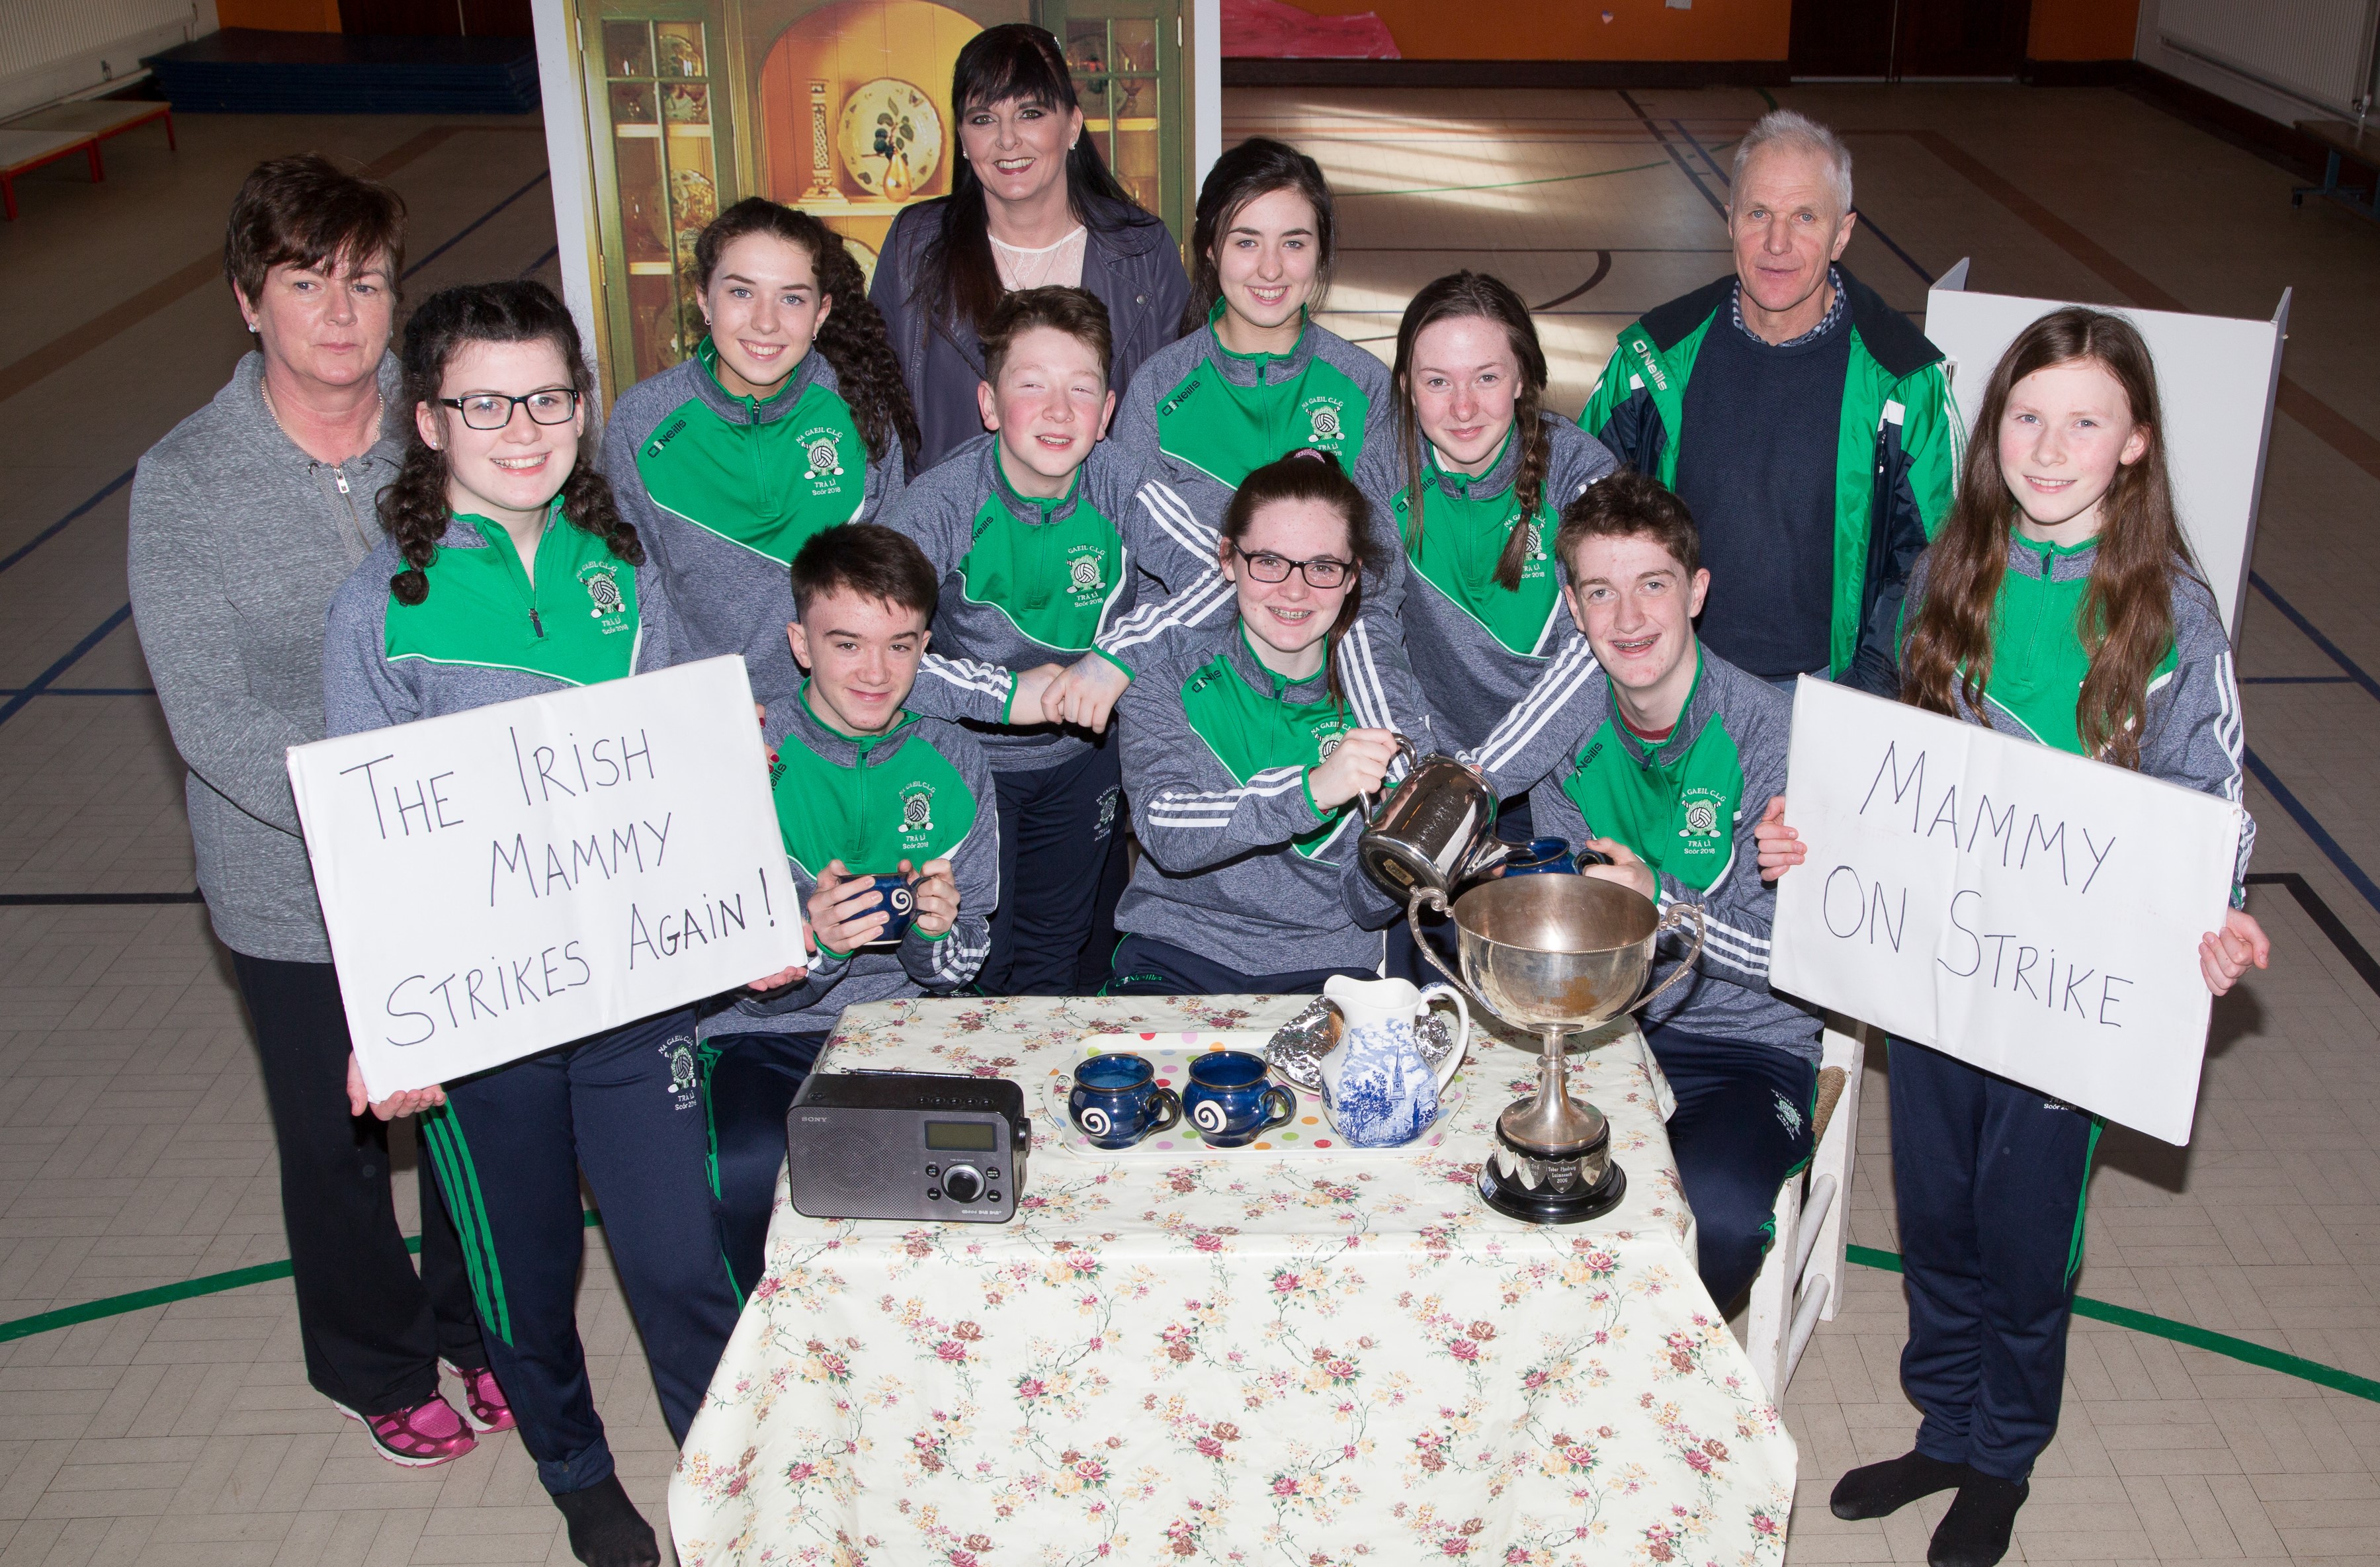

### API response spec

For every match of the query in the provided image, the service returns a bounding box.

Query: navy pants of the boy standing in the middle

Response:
[976,724,1123,995]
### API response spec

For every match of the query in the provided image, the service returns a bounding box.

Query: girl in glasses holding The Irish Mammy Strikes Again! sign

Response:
[323,283,738,1567]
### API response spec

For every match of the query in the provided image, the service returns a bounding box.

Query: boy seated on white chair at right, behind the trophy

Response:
[1464,472,1818,1310]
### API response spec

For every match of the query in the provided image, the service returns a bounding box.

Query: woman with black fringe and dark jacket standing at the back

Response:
[871,21,1190,469]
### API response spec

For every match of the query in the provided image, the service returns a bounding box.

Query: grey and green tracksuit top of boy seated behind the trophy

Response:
[1471,636,1820,1062]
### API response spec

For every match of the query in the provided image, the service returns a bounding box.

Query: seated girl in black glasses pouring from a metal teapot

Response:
[1107,450,1397,995]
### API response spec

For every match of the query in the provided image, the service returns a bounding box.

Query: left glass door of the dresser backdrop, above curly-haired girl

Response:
[583,0,736,393]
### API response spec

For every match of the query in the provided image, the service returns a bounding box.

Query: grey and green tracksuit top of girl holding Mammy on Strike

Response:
[1902,529,2256,908]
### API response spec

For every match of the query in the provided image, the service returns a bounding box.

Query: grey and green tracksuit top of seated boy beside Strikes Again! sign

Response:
[697,686,999,1038]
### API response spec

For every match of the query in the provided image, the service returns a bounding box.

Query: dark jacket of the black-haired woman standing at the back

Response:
[869,198,1190,469]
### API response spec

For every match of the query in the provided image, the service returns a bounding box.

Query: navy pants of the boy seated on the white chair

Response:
[1644,1027,1818,1310]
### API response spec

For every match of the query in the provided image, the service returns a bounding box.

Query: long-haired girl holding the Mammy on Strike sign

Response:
[1759,305,2273,1567]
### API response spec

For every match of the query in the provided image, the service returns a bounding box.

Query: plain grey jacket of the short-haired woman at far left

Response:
[128,353,402,962]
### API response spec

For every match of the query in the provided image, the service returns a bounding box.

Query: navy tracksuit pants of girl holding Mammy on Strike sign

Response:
[1890,1038,2099,1479]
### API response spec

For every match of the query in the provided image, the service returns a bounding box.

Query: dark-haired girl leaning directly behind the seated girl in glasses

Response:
[1080,136,1430,750]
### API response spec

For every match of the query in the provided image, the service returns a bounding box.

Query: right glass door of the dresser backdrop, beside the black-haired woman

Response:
[1035,0,1197,241]
